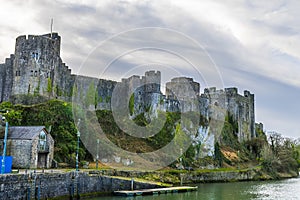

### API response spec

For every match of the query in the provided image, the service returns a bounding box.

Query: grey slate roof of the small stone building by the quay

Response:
[7,126,45,140]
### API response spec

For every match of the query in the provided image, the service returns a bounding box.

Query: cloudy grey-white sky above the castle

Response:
[0,0,300,138]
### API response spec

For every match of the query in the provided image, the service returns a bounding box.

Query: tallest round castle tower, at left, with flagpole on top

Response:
[12,33,61,97]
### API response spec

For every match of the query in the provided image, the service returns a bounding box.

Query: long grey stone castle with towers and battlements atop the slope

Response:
[0,33,256,141]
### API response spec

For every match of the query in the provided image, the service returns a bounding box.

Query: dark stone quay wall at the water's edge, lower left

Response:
[0,172,159,199]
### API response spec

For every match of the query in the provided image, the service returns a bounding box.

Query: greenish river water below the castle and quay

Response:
[89,178,300,200]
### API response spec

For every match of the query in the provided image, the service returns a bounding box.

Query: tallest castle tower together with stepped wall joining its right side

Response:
[10,33,74,100]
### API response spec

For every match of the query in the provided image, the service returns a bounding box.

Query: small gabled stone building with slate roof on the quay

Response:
[1,126,54,168]
